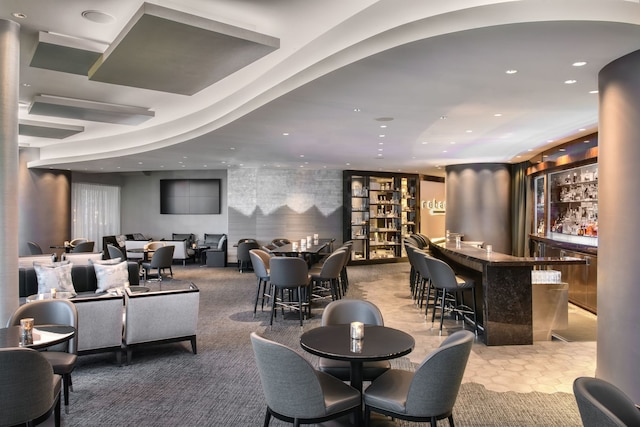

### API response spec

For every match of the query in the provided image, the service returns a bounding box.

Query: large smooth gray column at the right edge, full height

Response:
[596,50,640,402]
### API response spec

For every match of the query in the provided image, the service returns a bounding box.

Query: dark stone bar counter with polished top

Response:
[430,242,585,345]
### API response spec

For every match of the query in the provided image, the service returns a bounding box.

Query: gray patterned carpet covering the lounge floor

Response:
[62,266,581,426]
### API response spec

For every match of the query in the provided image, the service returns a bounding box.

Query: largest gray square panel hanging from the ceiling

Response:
[89,3,280,95]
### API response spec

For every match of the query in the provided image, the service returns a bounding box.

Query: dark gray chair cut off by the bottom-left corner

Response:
[0,347,61,427]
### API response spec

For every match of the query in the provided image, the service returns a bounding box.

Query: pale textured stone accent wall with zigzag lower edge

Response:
[228,169,342,262]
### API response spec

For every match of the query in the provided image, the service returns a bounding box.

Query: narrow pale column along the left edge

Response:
[0,20,20,325]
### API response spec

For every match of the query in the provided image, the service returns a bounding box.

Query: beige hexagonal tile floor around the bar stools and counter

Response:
[364,264,596,393]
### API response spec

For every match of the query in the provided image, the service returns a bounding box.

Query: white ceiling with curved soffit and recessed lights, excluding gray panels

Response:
[0,0,640,175]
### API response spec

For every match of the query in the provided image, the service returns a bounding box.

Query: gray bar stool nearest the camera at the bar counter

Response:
[425,255,478,336]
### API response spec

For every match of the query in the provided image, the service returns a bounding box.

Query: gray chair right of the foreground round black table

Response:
[363,330,475,427]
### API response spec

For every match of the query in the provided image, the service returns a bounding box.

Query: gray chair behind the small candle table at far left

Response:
[7,299,78,412]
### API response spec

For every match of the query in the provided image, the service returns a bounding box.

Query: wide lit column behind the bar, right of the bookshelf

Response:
[445,163,511,254]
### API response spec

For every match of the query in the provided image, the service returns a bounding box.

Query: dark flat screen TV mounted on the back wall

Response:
[160,179,220,215]
